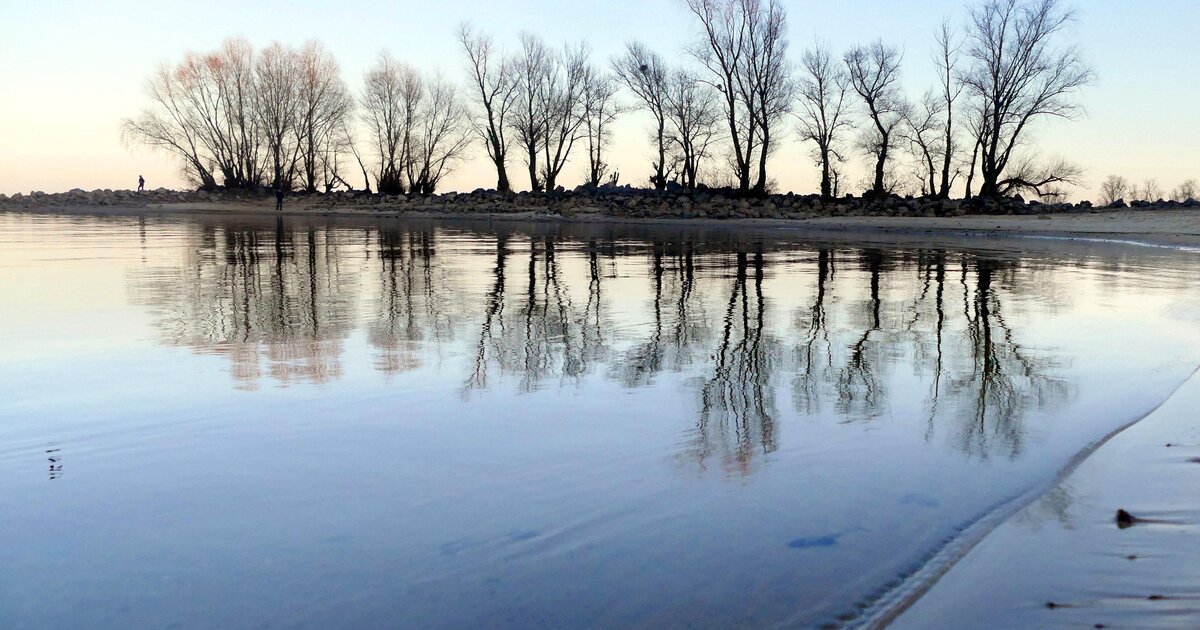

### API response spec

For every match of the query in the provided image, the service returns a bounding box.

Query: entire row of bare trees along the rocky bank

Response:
[125,0,1092,197]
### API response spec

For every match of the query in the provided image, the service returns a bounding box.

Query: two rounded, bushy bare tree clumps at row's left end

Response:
[122,40,470,193]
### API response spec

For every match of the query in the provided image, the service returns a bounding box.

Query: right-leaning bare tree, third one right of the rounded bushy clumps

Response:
[539,44,592,191]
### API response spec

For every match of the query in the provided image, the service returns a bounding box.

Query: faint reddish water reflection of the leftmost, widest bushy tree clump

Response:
[131,218,358,389]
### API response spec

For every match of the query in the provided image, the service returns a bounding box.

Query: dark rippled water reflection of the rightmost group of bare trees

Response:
[791,248,1073,456]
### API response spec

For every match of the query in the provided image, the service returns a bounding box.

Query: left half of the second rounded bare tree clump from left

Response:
[361,53,424,194]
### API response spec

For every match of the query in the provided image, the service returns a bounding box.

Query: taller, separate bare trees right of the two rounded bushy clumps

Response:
[460,0,1092,197]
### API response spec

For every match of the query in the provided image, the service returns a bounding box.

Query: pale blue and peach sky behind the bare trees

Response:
[0,0,1200,198]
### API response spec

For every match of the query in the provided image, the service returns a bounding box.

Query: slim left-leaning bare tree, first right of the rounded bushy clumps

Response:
[458,24,517,192]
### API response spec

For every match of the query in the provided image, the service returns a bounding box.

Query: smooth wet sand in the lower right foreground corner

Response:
[893,376,1200,628]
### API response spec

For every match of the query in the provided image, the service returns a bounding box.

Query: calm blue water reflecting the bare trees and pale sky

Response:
[0,214,1200,628]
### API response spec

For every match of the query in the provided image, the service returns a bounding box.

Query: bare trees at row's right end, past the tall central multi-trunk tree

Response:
[796,0,1092,197]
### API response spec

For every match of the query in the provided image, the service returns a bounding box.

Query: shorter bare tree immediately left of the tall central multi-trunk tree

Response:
[665,70,721,190]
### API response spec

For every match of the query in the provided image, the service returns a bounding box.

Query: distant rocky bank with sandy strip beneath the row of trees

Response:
[7,190,1200,246]
